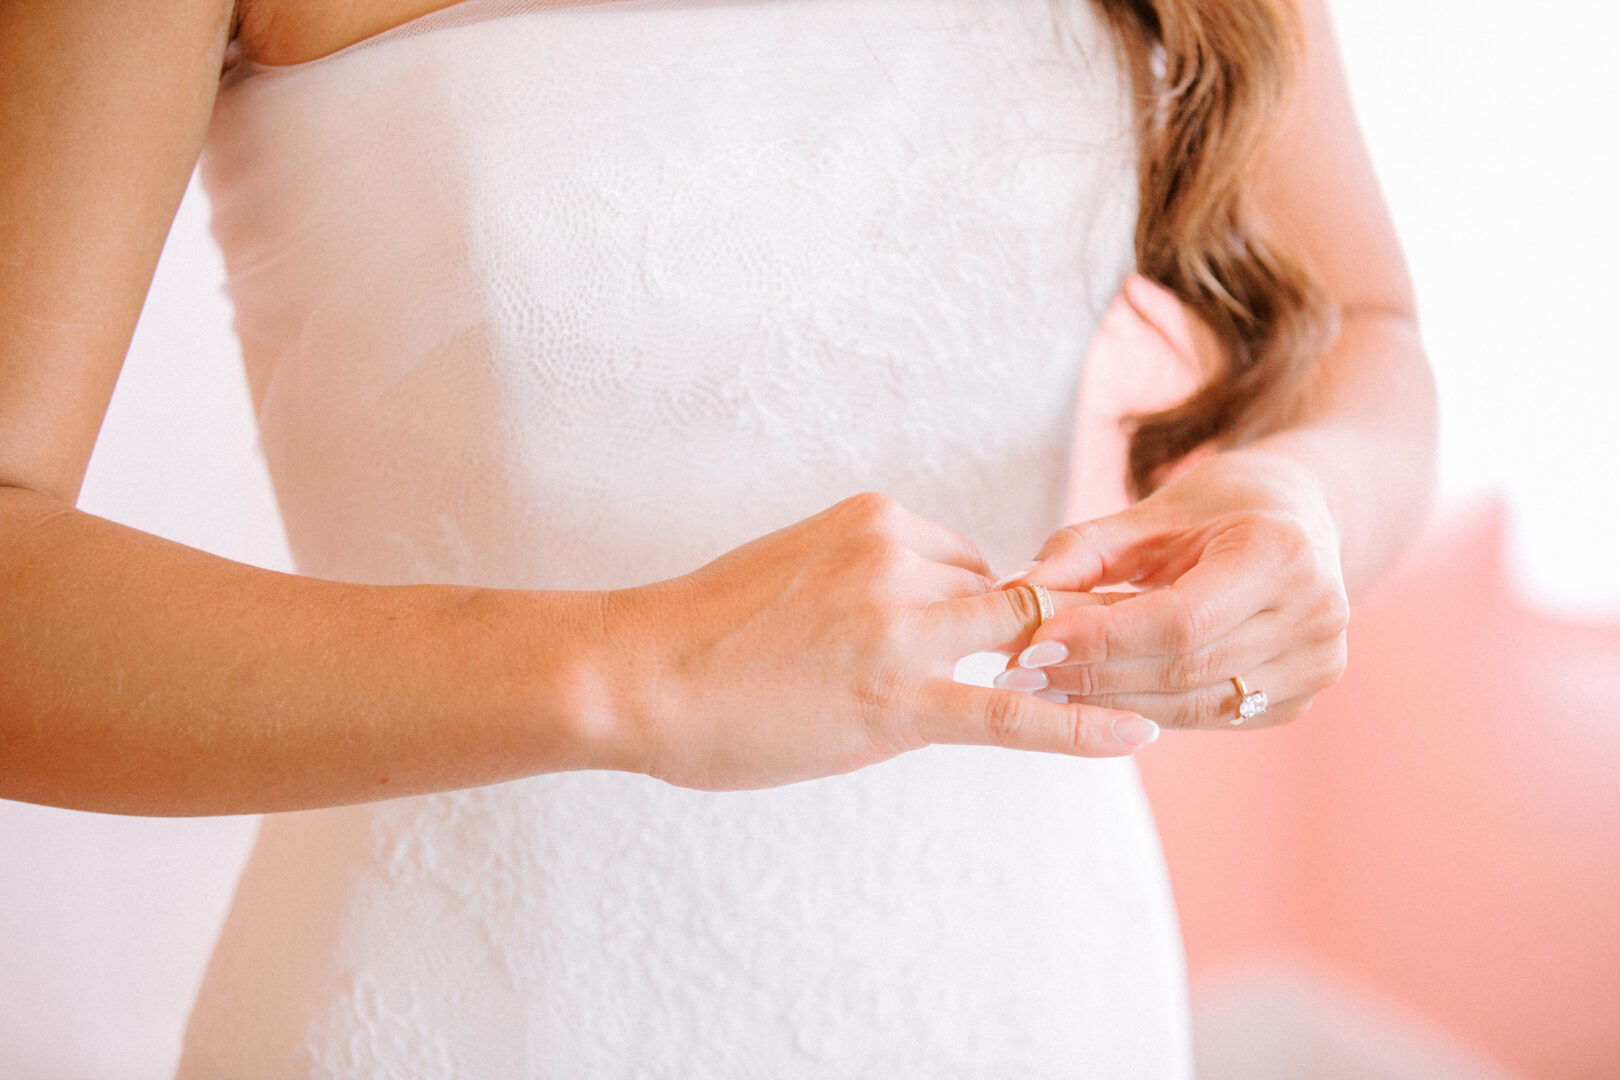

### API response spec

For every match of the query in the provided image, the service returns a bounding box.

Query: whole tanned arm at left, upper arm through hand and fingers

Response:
[0,0,1159,814]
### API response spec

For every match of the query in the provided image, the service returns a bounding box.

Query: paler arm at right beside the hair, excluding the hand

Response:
[1218,0,1439,596]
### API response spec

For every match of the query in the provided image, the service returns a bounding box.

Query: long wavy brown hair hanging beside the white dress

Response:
[1082,0,1337,497]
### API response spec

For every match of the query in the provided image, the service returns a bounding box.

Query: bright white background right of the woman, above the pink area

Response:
[1333,0,1620,617]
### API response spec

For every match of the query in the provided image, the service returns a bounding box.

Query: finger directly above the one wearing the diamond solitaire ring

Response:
[1036,610,1296,696]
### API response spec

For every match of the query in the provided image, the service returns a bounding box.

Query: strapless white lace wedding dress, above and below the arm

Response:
[180,0,1191,1080]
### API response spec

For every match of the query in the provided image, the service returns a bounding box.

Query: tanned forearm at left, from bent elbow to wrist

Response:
[0,487,611,814]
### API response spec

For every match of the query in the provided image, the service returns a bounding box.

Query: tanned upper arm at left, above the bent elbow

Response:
[0,0,232,502]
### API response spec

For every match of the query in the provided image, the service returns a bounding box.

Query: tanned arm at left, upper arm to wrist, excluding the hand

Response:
[0,0,622,814]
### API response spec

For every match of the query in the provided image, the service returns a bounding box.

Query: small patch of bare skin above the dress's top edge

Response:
[237,0,455,63]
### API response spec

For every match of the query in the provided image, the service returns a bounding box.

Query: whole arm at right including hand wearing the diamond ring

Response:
[998,0,1437,729]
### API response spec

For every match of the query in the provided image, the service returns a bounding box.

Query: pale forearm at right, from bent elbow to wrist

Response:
[1233,309,1439,599]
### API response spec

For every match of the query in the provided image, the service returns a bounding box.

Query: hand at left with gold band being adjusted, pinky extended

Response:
[589,492,1157,790]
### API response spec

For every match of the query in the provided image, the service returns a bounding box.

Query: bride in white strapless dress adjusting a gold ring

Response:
[0,0,1435,1078]
